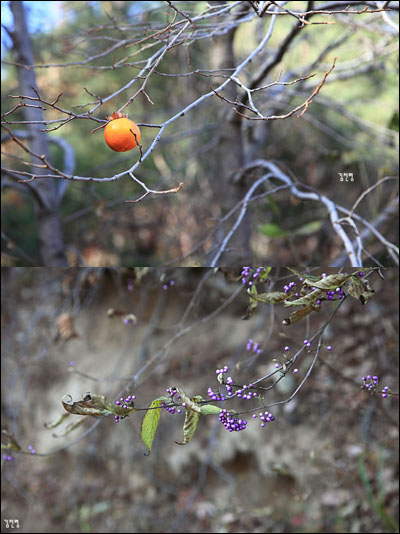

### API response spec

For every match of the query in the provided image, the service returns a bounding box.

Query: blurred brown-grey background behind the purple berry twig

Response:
[1,268,399,533]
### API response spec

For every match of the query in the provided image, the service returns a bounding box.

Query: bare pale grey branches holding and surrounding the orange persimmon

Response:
[2,2,394,188]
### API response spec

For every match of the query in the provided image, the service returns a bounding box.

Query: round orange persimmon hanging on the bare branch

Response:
[104,113,140,152]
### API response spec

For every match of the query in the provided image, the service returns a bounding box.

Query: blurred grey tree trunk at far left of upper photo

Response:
[10,1,67,267]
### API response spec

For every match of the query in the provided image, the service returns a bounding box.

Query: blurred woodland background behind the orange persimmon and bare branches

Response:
[1,1,399,266]
